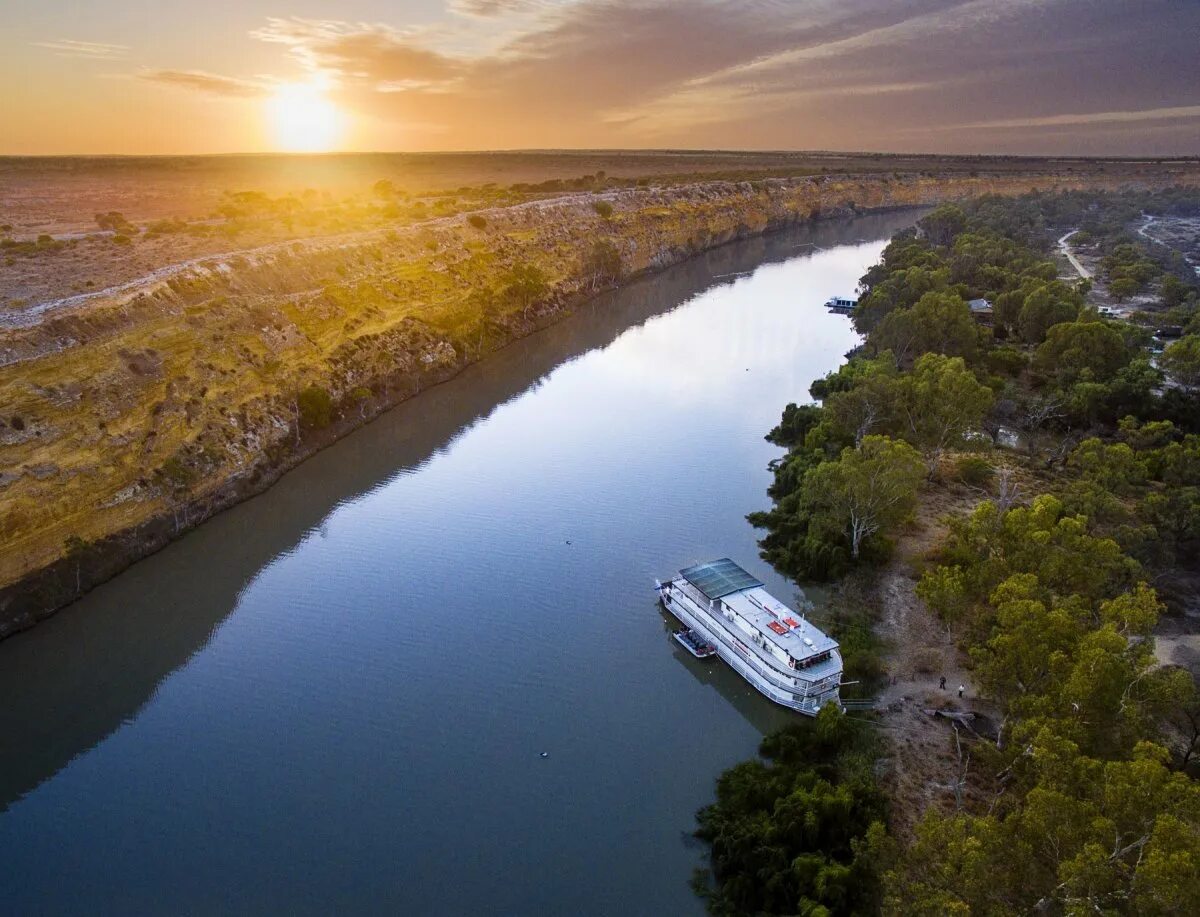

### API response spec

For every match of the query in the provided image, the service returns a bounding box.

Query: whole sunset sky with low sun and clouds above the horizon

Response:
[0,0,1200,156]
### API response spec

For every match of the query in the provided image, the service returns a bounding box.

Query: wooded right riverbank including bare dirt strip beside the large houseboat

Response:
[698,190,1200,913]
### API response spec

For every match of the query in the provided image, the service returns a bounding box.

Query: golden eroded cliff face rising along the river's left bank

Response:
[0,174,1185,635]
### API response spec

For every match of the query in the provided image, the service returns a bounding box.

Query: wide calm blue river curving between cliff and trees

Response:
[0,212,916,915]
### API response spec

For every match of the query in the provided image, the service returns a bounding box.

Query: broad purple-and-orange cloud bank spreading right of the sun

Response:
[229,0,1200,152]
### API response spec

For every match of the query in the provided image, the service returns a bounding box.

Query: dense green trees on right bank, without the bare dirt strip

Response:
[701,190,1200,915]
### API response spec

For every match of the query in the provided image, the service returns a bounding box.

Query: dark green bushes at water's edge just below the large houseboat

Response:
[696,707,887,917]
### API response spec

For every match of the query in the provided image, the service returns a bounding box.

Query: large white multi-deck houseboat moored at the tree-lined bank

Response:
[656,557,841,717]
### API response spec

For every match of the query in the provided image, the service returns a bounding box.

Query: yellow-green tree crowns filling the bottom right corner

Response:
[884,730,1200,917]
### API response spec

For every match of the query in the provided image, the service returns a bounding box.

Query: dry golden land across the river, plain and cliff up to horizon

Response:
[0,154,1198,634]
